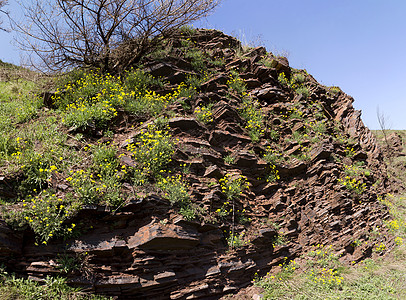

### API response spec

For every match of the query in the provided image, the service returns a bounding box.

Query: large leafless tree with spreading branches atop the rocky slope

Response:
[14,0,221,71]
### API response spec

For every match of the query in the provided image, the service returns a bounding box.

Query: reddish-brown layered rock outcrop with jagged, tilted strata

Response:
[0,30,392,299]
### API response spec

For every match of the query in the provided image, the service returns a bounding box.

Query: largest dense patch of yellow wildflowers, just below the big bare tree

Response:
[53,72,186,127]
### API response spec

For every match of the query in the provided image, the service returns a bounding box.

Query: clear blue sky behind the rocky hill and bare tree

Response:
[0,0,406,129]
